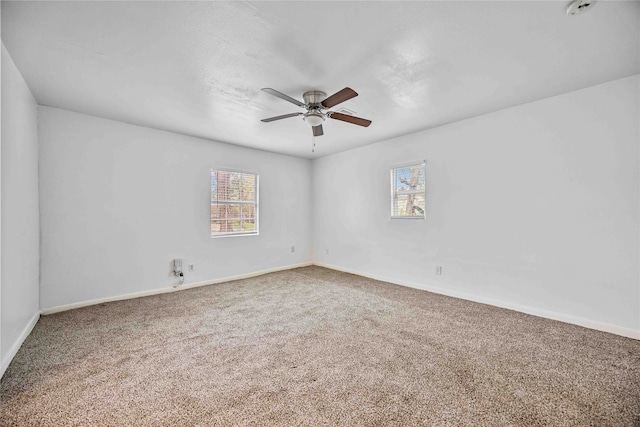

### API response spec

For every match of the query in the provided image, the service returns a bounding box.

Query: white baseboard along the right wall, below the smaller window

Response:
[313,262,640,340]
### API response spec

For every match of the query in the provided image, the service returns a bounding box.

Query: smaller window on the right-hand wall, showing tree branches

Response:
[391,162,425,219]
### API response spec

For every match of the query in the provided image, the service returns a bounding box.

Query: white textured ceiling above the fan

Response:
[2,0,640,158]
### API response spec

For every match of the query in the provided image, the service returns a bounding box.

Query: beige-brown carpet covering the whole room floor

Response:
[0,267,640,427]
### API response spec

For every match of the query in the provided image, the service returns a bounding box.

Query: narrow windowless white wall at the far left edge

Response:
[0,44,40,375]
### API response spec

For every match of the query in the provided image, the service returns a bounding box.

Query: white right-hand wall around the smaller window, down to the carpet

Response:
[313,75,640,338]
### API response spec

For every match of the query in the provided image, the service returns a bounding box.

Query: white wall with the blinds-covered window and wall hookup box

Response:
[39,106,311,310]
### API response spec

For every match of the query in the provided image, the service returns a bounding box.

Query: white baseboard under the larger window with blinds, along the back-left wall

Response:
[42,262,312,316]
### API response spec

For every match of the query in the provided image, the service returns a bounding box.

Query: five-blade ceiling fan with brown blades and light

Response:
[262,87,371,136]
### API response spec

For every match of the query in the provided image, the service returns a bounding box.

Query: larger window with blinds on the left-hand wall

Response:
[211,169,258,237]
